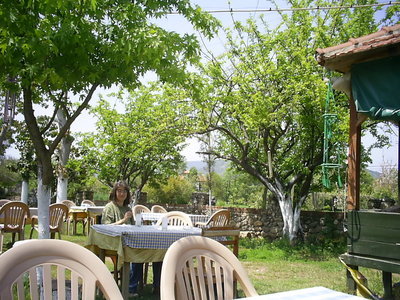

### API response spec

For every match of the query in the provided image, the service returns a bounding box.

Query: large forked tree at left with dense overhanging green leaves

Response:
[0,0,217,238]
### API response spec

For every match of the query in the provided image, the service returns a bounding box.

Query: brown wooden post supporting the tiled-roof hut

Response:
[347,97,361,210]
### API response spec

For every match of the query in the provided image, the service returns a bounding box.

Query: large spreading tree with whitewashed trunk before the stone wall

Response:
[189,0,377,242]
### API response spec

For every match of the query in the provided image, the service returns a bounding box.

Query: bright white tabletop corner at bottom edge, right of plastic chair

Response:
[241,286,364,300]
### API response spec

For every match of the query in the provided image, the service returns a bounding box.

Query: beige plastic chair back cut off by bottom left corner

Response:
[0,239,123,300]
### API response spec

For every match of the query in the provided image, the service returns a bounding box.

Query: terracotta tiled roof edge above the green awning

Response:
[316,24,400,73]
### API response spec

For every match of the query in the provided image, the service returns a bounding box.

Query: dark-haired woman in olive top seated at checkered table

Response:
[101,181,143,294]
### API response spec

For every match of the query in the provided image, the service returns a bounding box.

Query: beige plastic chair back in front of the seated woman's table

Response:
[160,236,258,300]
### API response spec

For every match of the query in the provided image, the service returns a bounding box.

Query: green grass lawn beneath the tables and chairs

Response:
[3,224,400,299]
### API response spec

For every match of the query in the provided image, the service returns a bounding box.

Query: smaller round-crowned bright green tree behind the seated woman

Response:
[80,85,190,201]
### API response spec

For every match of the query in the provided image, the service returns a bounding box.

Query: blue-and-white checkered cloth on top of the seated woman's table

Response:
[92,225,201,249]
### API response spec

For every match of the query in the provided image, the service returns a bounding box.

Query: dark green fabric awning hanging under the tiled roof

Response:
[351,56,400,121]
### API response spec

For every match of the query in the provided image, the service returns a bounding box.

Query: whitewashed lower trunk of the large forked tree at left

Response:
[37,165,51,239]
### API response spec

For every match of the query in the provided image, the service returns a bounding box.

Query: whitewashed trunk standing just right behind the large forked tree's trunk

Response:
[56,109,73,203]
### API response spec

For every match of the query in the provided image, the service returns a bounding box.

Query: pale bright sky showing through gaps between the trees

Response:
[7,0,398,172]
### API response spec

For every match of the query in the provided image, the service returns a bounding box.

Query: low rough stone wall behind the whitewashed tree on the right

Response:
[164,205,344,240]
